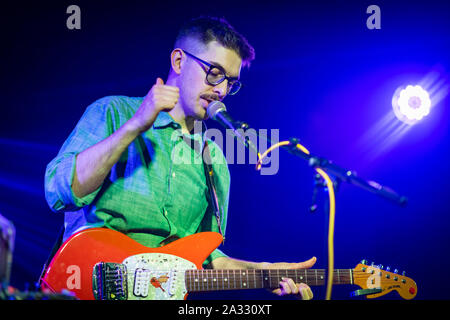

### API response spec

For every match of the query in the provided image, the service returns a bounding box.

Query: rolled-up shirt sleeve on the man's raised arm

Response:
[44,97,119,212]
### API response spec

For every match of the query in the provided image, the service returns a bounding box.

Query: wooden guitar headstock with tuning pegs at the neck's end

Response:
[353,260,417,300]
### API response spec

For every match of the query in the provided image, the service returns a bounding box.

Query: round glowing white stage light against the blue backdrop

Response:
[392,85,431,125]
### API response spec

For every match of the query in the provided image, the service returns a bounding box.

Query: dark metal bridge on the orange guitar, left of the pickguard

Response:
[92,262,128,300]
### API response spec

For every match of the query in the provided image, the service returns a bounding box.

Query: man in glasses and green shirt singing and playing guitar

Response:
[45,17,315,299]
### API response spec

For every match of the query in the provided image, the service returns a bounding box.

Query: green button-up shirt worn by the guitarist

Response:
[45,96,230,264]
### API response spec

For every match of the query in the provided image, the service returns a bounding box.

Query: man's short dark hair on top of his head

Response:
[175,16,255,67]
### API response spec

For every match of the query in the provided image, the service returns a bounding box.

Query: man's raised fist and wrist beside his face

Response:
[131,78,180,133]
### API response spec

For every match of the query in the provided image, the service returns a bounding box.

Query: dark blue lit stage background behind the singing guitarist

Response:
[0,0,450,299]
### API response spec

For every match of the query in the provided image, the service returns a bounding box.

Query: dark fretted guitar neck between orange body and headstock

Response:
[185,269,353,292]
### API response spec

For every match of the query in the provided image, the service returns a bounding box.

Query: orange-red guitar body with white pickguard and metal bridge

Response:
[42,228,222,300]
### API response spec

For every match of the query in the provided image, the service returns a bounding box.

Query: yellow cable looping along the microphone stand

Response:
[256,141,336,300]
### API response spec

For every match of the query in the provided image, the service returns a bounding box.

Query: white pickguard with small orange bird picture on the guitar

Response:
[122,253,197,300]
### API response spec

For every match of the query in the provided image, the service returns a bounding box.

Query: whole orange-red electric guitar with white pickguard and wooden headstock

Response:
[41,228,417,300]
